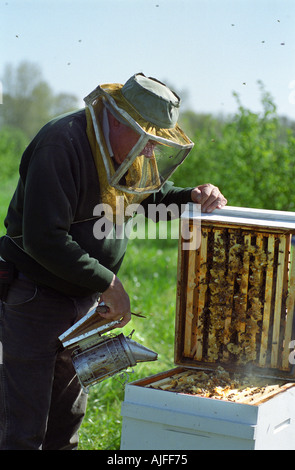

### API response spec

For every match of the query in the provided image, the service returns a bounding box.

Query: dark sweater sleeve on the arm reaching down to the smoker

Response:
[23,145,113,292]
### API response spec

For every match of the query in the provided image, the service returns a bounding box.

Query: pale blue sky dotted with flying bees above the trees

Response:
[0,0,295,120]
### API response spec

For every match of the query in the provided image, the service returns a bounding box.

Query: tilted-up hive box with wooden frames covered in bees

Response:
[175,207,295,380]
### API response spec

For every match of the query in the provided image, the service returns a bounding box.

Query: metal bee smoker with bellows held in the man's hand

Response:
[59,306,158,393]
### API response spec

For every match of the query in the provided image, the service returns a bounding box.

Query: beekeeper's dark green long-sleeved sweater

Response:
[0,110,191,296]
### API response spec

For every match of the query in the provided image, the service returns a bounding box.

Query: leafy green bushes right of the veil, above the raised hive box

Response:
[173,85,295,211]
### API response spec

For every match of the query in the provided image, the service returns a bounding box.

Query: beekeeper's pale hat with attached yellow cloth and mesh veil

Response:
[84,74,193,203]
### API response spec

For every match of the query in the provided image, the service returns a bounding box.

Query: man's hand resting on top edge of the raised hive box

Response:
[191,183,227,212]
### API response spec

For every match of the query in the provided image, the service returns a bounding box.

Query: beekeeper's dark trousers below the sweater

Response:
[0,279,97,450]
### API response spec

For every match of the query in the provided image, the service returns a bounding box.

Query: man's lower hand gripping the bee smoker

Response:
[100,274,131,328]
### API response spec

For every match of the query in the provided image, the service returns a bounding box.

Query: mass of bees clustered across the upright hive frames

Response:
[187,228,288,365]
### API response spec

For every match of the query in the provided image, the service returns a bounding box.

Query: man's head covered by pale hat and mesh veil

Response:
[85,73,193,193]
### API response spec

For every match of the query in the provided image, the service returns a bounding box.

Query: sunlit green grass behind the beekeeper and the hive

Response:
[0,181,178,450]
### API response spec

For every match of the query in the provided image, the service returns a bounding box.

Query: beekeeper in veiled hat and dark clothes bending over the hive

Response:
[0,74,227,450]
